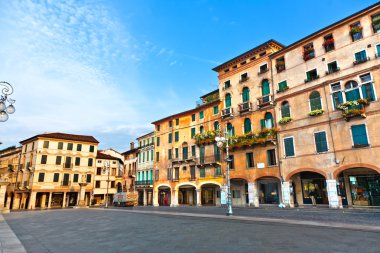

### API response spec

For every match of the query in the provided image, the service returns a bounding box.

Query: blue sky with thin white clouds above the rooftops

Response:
[0,0,376,151]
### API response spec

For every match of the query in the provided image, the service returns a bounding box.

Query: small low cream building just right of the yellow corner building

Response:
[92,151,124,205]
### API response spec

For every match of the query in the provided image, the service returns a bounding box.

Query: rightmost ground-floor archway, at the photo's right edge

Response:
[337,167,380,207]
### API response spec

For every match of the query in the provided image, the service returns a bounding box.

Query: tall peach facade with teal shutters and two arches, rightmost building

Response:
[270,4,380,208]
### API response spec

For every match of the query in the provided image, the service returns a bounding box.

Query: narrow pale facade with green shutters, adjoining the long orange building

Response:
[136,132,154,206]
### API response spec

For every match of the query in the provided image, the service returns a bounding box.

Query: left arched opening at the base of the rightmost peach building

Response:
[290,170,329,206]
